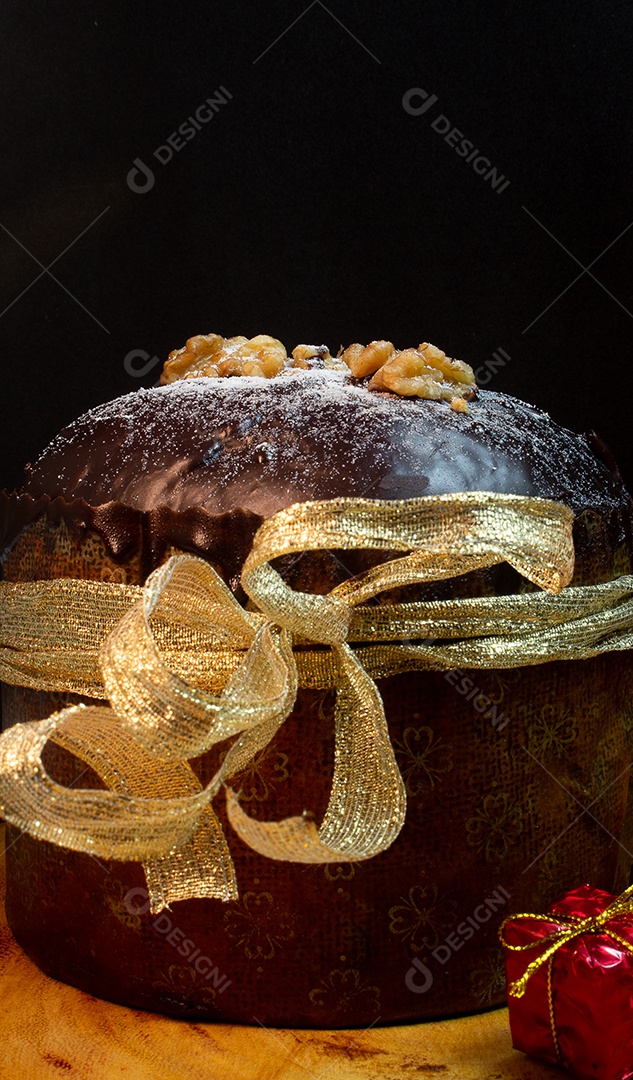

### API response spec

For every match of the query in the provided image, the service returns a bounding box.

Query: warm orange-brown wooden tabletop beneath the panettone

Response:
[0,825,566,1080]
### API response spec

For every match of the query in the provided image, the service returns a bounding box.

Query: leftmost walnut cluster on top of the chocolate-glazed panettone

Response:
[161,334,287,383]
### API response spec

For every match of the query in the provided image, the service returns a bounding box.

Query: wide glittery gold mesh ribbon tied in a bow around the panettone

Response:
[0,492,633,912]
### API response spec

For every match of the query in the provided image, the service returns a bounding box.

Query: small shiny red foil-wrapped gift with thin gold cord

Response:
[499,885,633,1080]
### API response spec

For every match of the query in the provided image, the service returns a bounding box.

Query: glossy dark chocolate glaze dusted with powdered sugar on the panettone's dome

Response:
[0,370,630,577]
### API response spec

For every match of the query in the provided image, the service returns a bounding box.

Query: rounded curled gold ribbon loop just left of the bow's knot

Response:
[100,555,292,761]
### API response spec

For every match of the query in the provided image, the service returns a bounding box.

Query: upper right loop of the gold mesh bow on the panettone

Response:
[242,491,574,604]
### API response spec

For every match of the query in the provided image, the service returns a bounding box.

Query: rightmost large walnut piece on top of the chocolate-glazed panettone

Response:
[369,341,476,413]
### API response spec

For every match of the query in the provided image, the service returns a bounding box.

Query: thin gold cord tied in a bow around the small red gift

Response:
[499,886,633,1061]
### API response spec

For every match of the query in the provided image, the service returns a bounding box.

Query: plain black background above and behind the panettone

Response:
[0,0,633,487]
